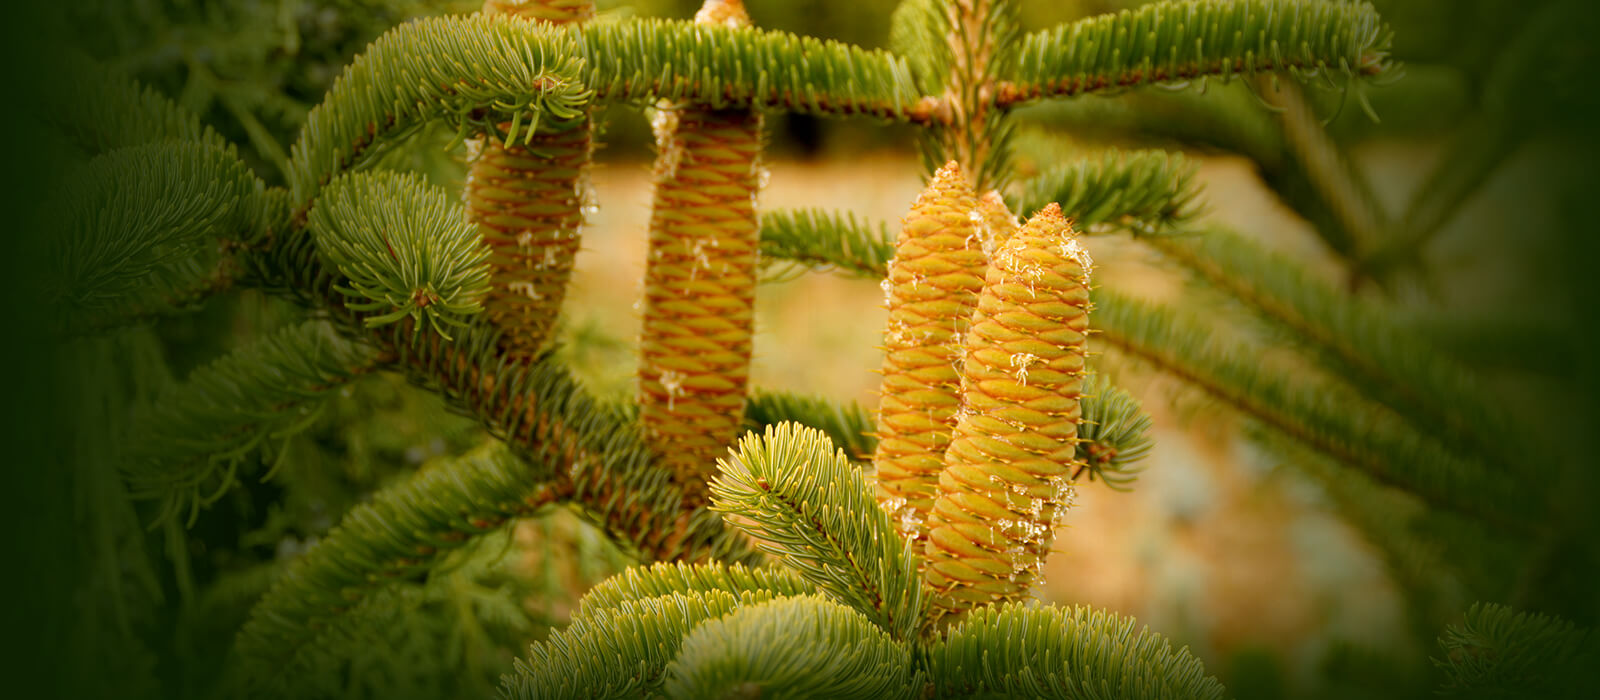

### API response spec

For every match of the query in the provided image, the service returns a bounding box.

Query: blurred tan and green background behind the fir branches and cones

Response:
[15,0,1595,698]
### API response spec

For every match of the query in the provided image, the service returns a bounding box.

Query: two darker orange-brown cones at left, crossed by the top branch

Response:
[466,0,762,503]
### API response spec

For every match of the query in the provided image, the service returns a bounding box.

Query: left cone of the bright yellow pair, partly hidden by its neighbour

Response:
[872,161,987,542]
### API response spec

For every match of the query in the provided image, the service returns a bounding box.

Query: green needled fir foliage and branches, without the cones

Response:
[53,0,1594,697]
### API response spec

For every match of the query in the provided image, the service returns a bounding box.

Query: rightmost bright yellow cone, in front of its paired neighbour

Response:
[925,205,1091,623]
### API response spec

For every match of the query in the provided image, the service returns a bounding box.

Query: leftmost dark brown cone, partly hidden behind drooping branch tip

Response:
[466,0,595,358]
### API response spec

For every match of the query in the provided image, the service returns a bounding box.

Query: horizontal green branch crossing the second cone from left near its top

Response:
[581,19,930,120]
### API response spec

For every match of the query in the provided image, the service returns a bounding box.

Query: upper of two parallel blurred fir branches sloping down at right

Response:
[1146,230,1516,478]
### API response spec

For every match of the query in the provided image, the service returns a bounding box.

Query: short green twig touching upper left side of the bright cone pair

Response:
[762,209,894,278]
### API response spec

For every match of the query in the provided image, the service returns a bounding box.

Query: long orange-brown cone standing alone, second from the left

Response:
[638,0,762,502]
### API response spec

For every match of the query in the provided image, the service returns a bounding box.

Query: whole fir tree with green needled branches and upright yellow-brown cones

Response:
[24,0,1600,698]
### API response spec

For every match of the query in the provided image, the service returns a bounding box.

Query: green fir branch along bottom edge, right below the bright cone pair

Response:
[928,603,1224,700]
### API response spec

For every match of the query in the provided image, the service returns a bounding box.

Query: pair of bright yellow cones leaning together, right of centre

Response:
[874,161,1093,615]
